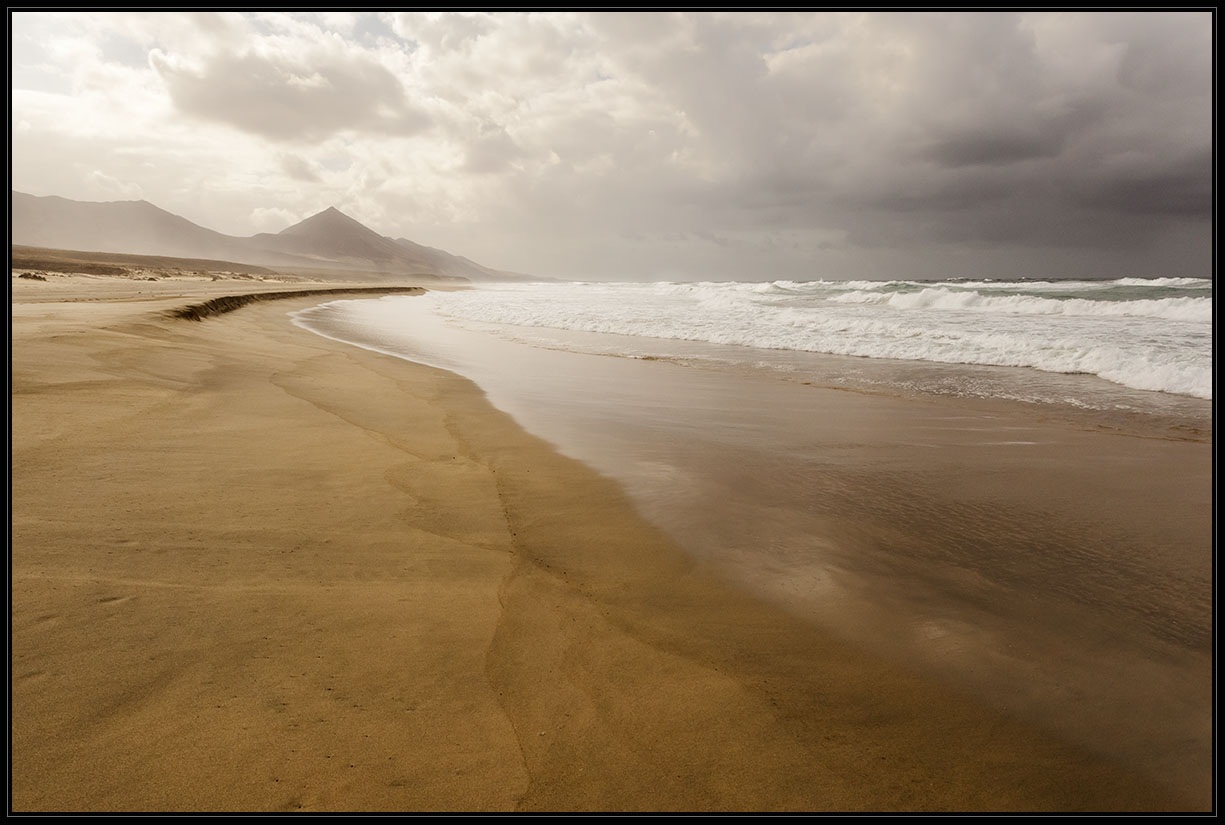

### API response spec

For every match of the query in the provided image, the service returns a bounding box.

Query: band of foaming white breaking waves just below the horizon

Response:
[357,278,1212,398]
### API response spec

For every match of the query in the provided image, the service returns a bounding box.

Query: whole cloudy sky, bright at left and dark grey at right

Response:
[10,11,1214,281]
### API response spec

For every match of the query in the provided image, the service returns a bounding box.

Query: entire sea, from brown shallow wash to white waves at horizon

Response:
[293,278,1213,797]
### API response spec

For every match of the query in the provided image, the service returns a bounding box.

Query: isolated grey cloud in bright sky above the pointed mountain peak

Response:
[149,50,429,141]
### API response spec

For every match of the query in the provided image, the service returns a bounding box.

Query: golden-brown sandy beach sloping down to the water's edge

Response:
[11,278,1187,812]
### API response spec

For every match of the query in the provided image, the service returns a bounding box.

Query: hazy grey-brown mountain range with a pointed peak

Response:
[11,191,533,281]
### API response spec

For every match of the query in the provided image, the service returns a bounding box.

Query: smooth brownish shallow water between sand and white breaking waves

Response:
[295,291,1212,802]
